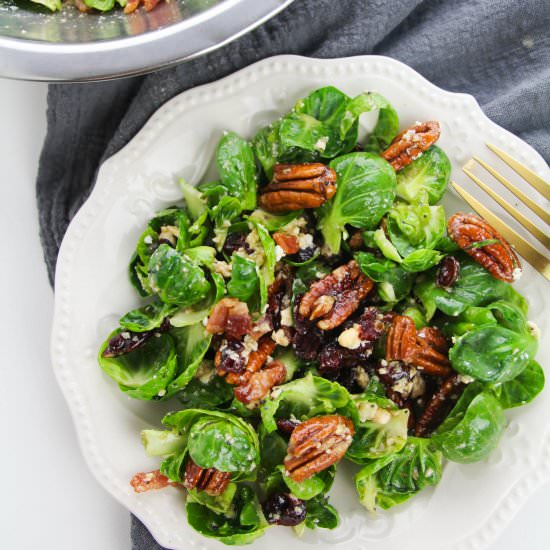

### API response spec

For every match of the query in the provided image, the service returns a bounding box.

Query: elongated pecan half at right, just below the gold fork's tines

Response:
[447,212,521,283]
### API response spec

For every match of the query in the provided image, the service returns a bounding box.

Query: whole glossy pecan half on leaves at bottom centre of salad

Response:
[284,414,355,483]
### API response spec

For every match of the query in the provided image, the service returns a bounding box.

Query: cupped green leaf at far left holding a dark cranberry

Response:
[98,329,177,400]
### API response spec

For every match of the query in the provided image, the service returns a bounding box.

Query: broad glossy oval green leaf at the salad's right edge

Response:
[449,326,537,383]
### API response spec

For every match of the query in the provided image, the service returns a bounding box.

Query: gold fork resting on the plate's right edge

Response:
[452,143,550,281]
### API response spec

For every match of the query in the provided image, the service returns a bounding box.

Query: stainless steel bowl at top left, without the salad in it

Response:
[0,0,293,81]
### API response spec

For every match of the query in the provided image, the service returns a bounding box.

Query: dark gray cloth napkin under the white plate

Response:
[37,0,550,550]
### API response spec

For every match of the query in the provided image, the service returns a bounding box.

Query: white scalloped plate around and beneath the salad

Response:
[52,56,550,550]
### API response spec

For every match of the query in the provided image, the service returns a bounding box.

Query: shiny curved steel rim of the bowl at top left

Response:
[0,0,294,82]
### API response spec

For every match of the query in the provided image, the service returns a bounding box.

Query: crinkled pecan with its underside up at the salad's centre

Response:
[298,260,374,330]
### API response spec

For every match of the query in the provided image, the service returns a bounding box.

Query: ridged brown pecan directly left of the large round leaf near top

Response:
[258,162,336,212]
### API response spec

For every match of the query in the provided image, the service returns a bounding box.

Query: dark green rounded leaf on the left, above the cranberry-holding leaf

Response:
[149,244,210,306]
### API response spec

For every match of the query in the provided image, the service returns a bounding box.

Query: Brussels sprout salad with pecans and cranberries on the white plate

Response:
[99,86,544,545]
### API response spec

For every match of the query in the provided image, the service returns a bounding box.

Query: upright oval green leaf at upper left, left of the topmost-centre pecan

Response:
[216,132,257,210]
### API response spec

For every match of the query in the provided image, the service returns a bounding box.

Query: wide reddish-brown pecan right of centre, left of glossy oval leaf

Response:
[386,315,452,376]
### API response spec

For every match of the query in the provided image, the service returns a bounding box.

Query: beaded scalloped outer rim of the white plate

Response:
[50,55,550,550]
